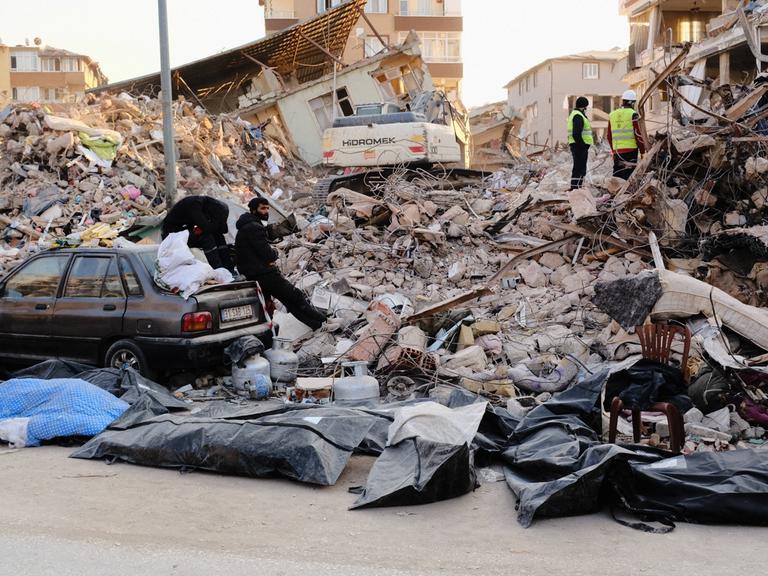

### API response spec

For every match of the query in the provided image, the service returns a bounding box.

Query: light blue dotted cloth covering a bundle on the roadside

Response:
[0,378,128,447]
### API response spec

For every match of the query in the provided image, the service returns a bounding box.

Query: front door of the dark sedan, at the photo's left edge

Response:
[0,254,70,360]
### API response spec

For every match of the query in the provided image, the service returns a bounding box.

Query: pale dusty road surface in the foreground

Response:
[0,447,765,576]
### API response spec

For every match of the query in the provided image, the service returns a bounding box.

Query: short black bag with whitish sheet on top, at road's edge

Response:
[352,402,486,509]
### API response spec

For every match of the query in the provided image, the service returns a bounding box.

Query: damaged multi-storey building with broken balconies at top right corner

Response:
[619,0,768,126]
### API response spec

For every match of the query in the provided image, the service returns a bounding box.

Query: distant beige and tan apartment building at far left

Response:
[0,45,107,102]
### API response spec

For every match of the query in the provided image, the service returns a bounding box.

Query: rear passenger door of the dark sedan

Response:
[51,254,125,364]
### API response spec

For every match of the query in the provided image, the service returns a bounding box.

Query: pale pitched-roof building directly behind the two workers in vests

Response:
[505,50,627,154]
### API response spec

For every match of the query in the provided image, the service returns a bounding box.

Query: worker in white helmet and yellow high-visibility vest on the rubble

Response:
[607,90,645,180]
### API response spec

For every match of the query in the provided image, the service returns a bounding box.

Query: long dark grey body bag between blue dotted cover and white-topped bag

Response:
[71,400,377,486]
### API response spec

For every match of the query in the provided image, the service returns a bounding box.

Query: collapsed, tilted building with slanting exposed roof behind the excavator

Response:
[93,0,448,165]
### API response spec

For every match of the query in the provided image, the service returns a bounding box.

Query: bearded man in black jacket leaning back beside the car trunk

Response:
[235,198,325,330]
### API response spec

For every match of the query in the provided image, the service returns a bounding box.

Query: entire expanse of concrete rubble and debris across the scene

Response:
[6,74,768,450]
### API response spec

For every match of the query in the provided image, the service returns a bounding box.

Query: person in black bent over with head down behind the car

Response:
[162,196,235,273]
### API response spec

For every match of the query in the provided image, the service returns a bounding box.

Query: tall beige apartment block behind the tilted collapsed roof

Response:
[259,0,464,99]
